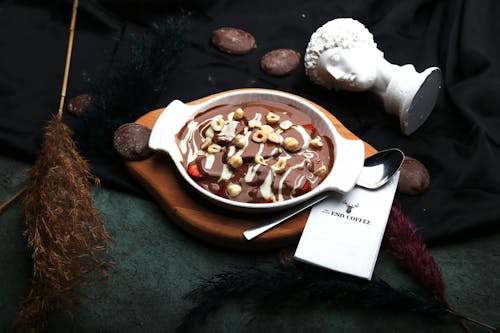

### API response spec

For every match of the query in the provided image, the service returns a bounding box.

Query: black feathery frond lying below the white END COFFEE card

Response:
[177,265,447,332]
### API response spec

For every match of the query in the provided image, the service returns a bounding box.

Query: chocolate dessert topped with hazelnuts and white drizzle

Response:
[176,101,334,203]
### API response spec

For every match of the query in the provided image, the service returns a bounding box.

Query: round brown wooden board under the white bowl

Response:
[125,88,376,250]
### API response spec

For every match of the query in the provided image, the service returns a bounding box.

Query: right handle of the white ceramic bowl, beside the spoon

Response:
[328,135,365,193]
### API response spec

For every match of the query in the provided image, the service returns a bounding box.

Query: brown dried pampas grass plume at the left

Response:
[15,116,111,332]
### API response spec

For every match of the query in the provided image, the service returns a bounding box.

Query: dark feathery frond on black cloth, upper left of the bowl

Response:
[75,14,190,152]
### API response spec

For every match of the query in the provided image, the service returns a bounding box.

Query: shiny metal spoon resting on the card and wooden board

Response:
[243,148,405,240]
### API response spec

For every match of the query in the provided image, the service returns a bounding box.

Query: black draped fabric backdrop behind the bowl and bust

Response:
[0,0,500,242]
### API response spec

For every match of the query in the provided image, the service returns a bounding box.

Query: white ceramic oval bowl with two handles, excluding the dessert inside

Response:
[149,89,365,213]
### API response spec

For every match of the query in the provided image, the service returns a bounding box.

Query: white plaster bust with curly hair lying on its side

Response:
[304,18,441,135]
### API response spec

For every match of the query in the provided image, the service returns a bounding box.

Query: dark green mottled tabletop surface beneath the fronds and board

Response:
[0,157,500,332]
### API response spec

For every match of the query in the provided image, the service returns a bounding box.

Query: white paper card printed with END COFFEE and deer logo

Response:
[295,172,399,280]
